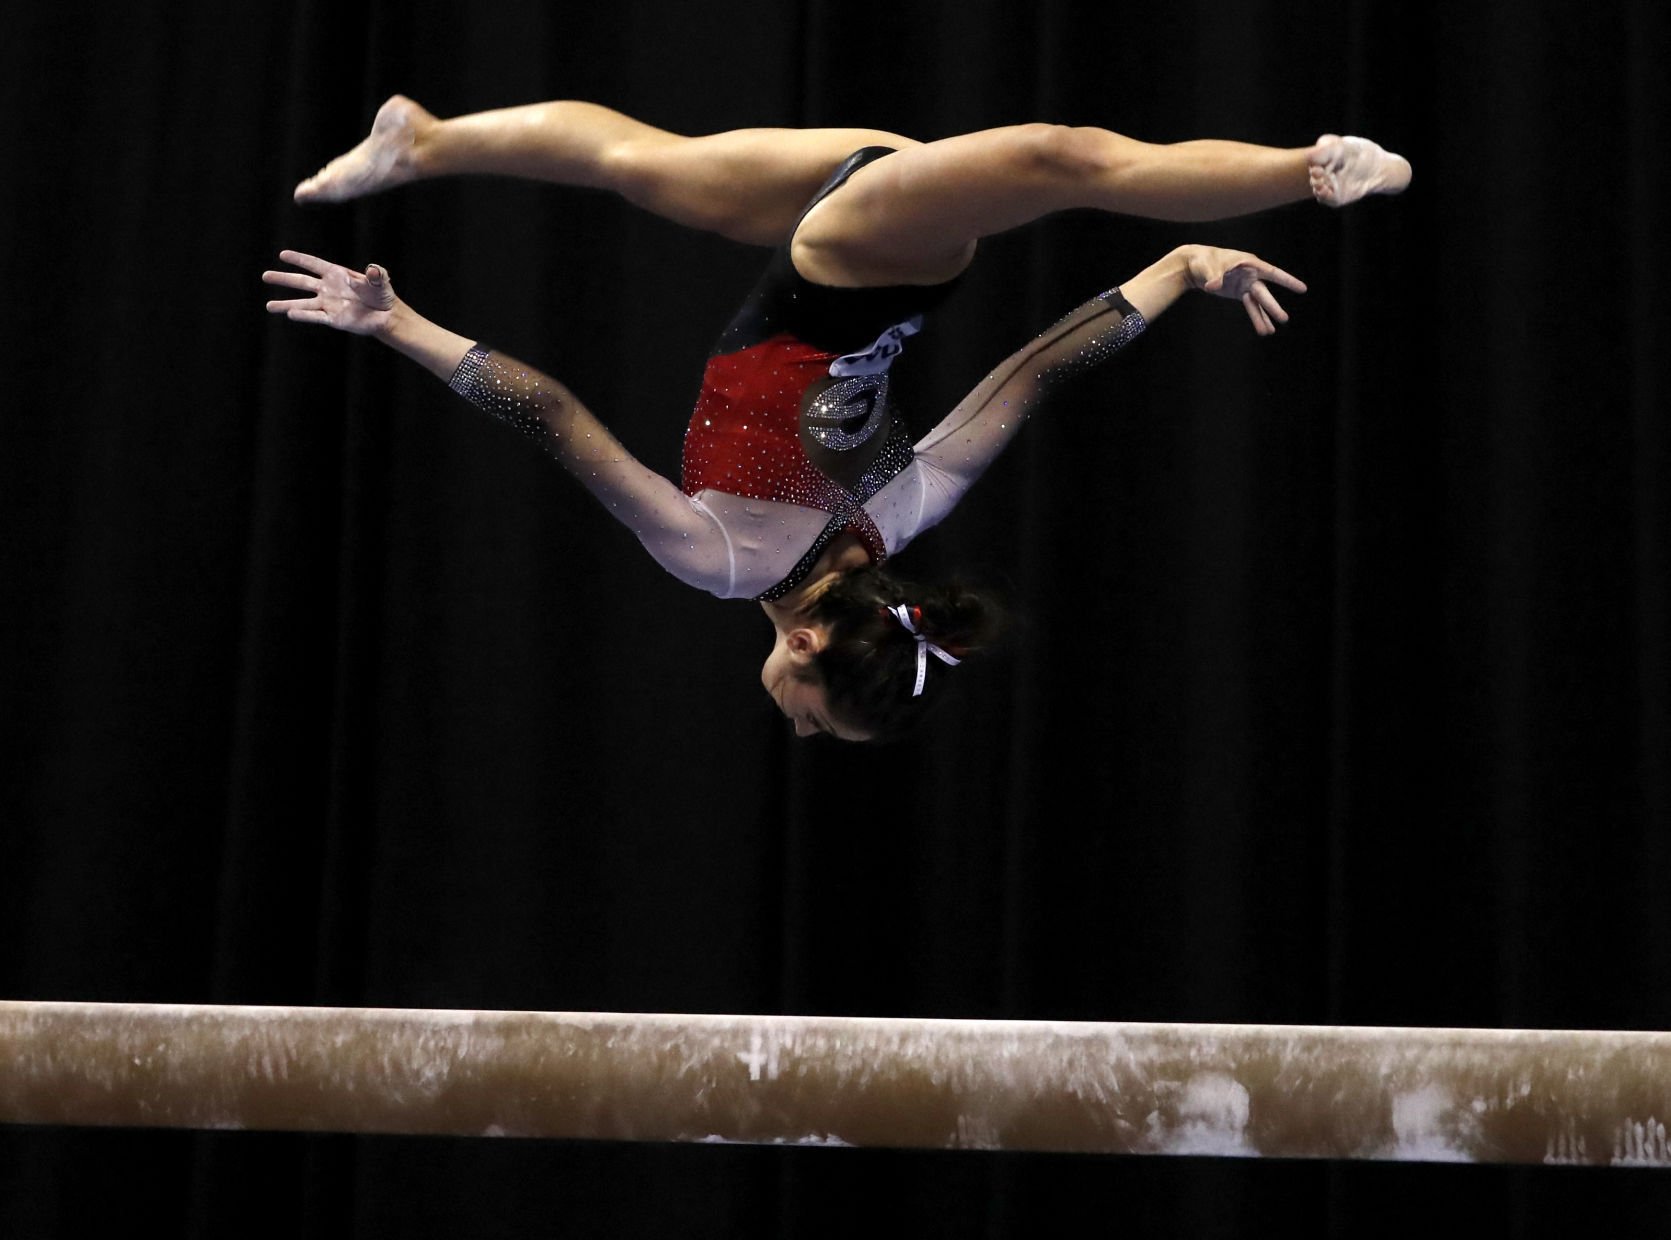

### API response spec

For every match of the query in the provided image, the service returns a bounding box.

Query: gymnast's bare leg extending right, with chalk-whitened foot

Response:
[794,124,1410,286]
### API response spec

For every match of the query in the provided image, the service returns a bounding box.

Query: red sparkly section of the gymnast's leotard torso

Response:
[680,333,887,560]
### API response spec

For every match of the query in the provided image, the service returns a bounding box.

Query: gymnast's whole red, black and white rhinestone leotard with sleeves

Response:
[451,155,1146,598]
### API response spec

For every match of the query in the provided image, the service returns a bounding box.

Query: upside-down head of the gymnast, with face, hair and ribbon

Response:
[760,565,1003,740]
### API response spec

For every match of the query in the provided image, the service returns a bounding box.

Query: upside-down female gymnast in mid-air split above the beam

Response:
[262,95,1410,740]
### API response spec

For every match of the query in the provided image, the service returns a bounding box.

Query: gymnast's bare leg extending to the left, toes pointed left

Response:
[296,95,919,246]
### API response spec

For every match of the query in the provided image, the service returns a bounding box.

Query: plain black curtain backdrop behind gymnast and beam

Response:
[0,0,1671,1237]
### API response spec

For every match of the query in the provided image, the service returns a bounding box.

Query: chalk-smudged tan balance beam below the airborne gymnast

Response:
[0,1001,1671,1166]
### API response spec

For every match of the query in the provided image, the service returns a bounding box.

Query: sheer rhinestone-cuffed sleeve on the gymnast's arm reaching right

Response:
[867,289,1148,551]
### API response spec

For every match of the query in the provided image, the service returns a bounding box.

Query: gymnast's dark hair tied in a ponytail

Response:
[804,565,1004,740]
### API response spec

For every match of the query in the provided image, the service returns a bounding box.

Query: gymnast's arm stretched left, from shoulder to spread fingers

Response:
[262,251,730,590]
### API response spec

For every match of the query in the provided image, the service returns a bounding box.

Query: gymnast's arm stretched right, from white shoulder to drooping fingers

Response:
[871,246,1305,551]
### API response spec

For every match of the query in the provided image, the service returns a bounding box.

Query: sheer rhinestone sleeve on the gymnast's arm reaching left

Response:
[448,344,735,598]
